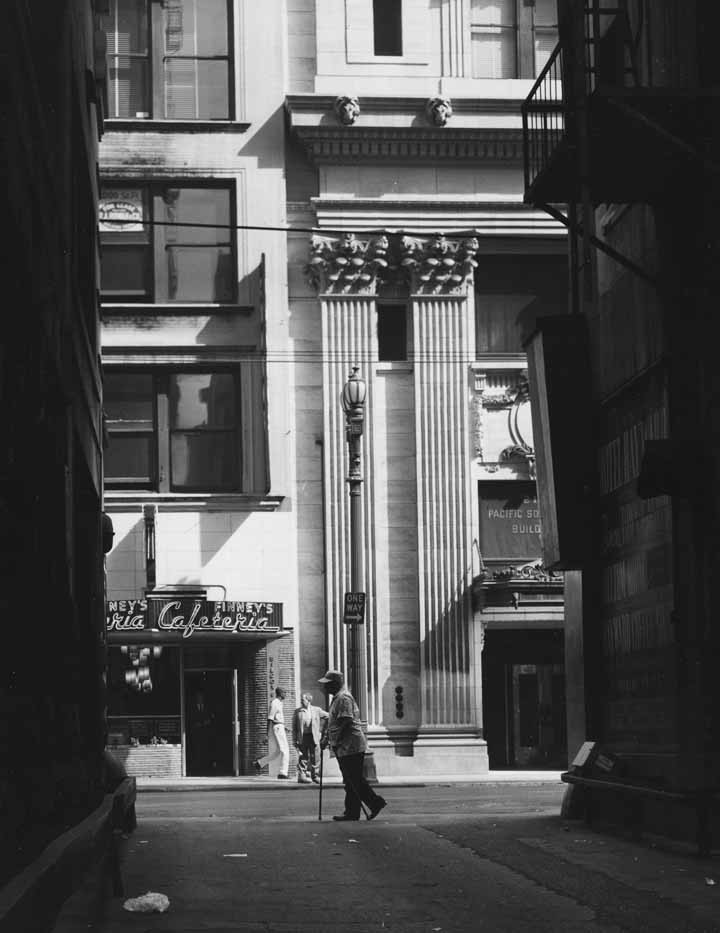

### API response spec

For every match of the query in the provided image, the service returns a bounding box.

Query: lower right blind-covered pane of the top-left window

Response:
[165,58,230,120]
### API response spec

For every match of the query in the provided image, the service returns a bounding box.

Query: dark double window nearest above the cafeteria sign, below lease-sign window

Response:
[104,371,241,493]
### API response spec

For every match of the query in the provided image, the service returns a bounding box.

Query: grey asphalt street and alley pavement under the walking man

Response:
[52,780,720,933]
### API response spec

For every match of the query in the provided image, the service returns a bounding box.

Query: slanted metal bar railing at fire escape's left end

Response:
[521,45,566,198]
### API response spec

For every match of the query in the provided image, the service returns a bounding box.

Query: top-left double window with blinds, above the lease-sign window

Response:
[105,0,231,120]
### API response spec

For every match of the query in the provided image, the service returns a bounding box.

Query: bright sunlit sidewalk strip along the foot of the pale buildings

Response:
[136,771,562,792]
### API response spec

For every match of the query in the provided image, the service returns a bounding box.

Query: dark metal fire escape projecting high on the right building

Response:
[522,0,720,279]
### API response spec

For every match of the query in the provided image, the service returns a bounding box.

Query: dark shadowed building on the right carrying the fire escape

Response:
[524,0,720,850]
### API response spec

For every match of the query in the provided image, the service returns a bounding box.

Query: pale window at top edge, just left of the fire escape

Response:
[470,0,558,78]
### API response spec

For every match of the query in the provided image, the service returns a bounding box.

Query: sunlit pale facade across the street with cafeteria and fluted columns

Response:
[101,0,567,777]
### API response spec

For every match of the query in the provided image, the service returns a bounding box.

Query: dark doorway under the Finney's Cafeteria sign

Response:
[185,670,235,777]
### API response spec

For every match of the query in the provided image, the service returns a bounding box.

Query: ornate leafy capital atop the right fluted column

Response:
[400,233,480,294]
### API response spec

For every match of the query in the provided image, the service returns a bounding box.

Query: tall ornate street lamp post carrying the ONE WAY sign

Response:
[342,366,367,731]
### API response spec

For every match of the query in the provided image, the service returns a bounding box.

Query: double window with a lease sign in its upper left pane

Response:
[100,184,237,303]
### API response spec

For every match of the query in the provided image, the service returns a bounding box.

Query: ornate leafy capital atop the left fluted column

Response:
[307,233,390,295]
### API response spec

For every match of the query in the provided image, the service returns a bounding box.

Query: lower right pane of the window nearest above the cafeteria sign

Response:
[170,431,239,491]
